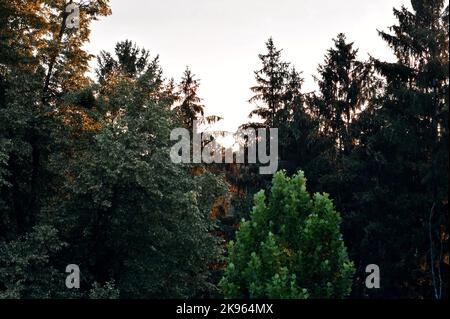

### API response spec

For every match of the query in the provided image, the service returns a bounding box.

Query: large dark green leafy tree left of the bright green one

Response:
[42,48,224,298]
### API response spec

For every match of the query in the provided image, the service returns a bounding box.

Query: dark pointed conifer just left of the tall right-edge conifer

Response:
[306,33,380,252]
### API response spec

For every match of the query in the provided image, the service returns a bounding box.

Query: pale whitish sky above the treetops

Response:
[82,0,409,131]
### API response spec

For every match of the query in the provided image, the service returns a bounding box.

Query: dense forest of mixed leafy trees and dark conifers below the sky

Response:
[0,0,449,299]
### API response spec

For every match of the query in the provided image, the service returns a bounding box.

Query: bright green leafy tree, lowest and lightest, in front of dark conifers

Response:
[219,172,354,298]
